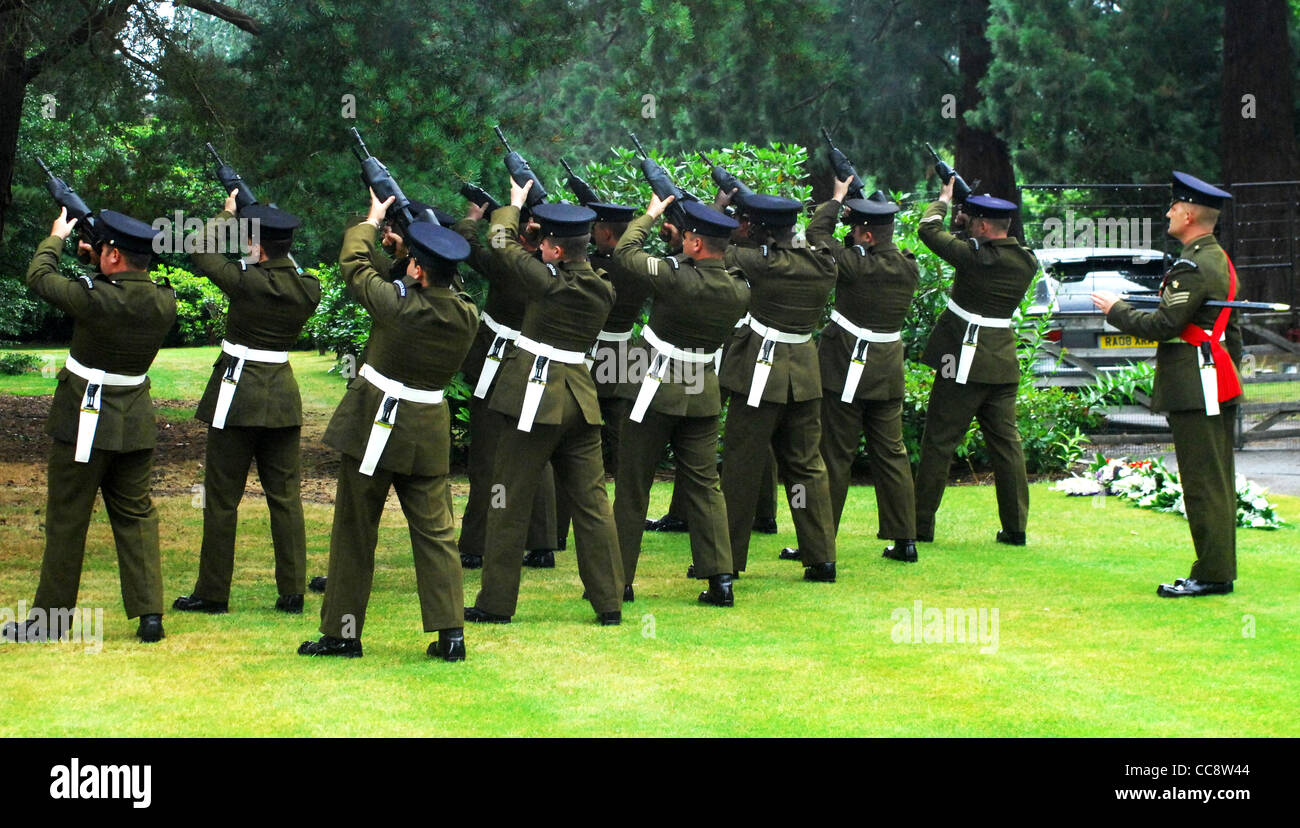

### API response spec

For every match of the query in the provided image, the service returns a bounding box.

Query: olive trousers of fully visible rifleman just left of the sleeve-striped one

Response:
[475,390,623,615]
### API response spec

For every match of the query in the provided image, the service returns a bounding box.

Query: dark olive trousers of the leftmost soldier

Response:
[33,439,163,619]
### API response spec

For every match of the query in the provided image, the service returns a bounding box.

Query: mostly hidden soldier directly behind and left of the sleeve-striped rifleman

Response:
[540,201,650,567]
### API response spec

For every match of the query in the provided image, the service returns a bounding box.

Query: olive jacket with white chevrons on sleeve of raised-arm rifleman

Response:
[614,216,749,417]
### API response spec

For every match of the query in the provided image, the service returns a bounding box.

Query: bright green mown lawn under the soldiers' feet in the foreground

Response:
[0,484,1300,736]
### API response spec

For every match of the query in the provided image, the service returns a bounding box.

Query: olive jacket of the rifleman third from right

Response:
[719,233,836,403]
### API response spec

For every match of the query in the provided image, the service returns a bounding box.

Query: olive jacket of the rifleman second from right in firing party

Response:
[807,200,920,399]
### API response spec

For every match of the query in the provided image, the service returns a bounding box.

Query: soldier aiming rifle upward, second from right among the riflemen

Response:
[807,175,919,562]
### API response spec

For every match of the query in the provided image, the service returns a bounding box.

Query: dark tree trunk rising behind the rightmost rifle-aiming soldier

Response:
[954,0,1024,240]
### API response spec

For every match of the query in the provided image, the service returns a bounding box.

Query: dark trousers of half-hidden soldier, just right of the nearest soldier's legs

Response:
[458,396,555,556]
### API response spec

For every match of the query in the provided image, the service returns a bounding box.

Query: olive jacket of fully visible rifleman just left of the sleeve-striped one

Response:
[488,205,614,425]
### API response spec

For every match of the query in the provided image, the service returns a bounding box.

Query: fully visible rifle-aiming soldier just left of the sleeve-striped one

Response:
[465,182,623,625]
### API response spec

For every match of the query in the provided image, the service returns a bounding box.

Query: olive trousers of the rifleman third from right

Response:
[723,391,835,572]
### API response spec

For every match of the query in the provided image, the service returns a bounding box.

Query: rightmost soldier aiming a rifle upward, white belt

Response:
[915,185,1039,546]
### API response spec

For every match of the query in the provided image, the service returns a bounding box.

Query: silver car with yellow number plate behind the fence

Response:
[1028,247,1167,386]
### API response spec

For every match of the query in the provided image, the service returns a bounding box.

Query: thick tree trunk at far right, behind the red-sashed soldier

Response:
[1216,0,1300,315]
